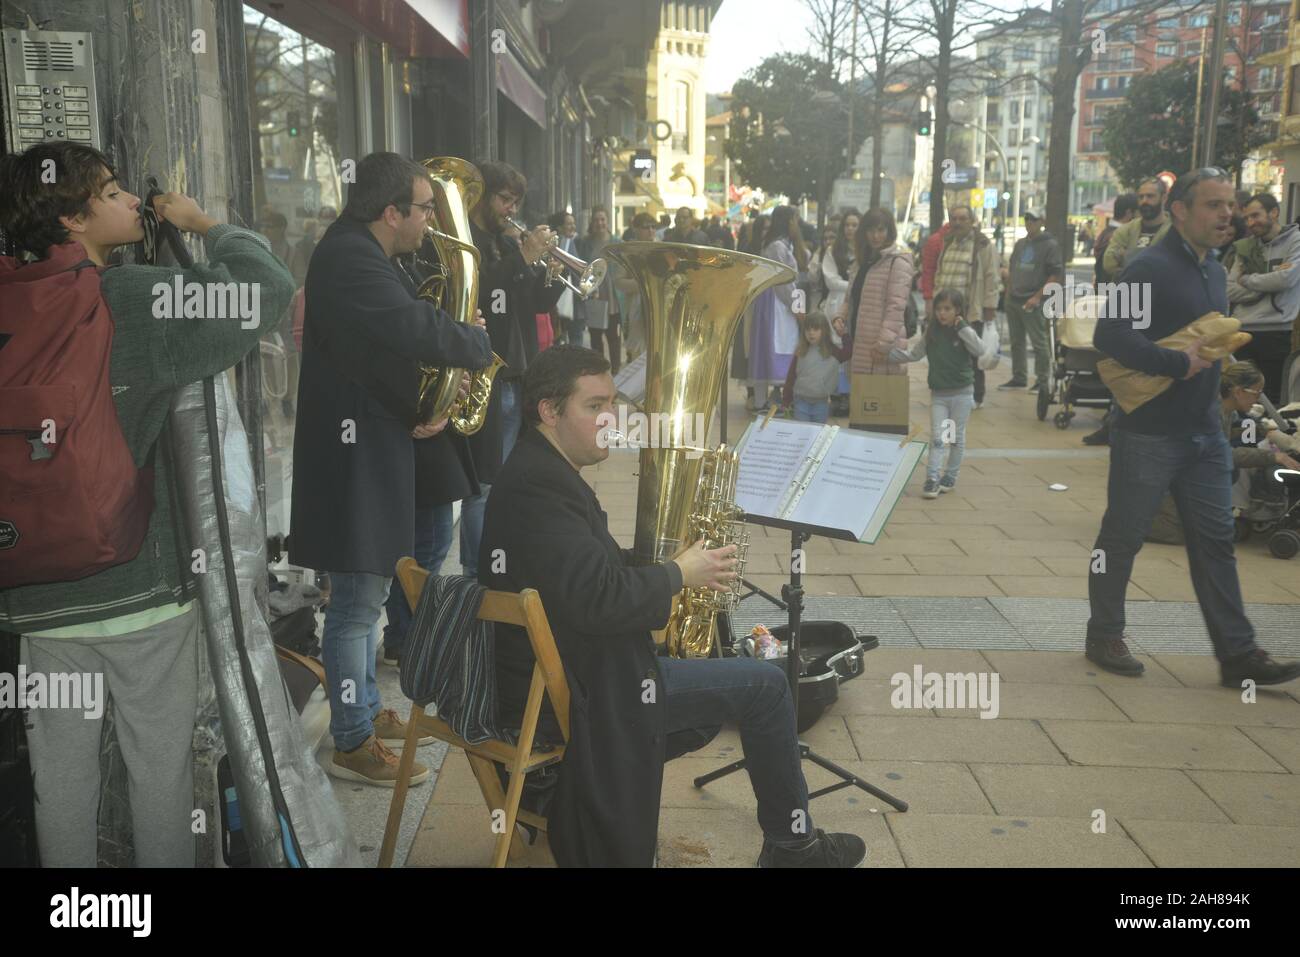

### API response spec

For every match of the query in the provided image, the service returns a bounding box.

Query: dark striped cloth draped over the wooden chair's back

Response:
[402,575,502,744]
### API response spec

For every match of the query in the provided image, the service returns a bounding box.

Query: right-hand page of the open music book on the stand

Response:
[785,429,907,540]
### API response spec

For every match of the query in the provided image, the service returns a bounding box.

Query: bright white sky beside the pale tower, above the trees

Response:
[705,0,1050,94]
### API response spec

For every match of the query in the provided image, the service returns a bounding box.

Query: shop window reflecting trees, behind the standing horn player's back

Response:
[243,5,343,536]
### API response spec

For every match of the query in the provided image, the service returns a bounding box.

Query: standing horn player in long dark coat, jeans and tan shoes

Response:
[289,152,491,787]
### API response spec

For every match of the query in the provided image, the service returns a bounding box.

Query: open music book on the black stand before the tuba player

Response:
[736,419,926,544]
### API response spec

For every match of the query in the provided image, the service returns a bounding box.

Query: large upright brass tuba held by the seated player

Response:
[603,243,794,658]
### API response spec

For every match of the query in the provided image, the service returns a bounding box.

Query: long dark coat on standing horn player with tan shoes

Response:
[289,220,491,576]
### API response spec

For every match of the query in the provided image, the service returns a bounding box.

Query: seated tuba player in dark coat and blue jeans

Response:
[478,346,866,867]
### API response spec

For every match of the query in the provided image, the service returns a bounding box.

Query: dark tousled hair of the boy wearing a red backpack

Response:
[0,143,117,259]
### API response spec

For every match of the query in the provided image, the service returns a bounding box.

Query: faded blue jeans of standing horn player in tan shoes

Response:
[321,572,391,752]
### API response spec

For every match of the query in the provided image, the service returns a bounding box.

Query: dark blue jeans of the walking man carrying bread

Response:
[1088,428,1255,661]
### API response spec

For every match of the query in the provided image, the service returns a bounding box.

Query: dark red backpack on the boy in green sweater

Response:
[0,243,153,588]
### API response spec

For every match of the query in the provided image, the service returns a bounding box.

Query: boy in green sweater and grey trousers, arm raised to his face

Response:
[0,143,294,867]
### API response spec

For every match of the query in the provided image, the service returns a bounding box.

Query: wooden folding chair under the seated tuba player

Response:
[380,558,569,867]
